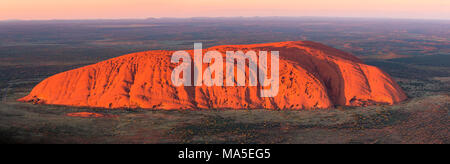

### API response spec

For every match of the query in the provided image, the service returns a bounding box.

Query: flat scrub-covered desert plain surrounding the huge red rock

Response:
[0,18,450,144]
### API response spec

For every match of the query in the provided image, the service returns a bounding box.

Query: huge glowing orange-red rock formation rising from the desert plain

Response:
[19,41,406,109]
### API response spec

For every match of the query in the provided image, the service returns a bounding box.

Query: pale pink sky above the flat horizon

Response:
[0,0,450,20]
